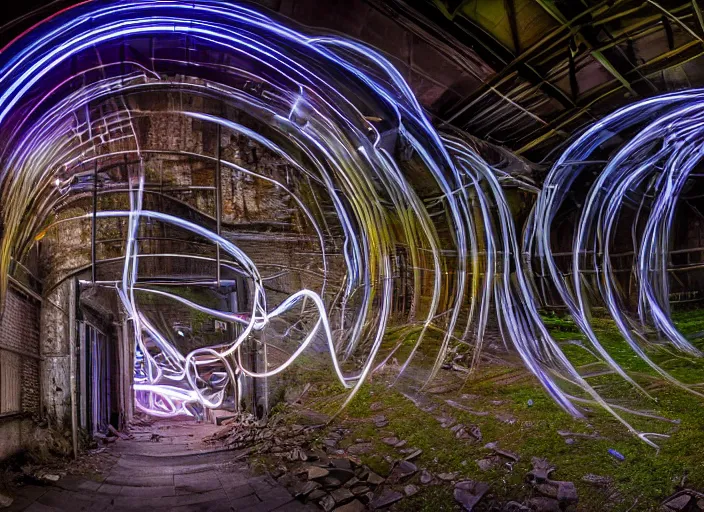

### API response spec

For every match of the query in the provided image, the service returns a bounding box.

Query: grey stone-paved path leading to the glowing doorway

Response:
[4,422,319,512]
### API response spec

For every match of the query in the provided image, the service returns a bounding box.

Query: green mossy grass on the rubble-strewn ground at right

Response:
[262,311,704,511]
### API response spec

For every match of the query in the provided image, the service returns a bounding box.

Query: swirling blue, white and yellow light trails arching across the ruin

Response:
[0,0,704,445]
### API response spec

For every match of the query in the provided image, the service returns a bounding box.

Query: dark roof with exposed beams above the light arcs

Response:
[4,0,704,163]
